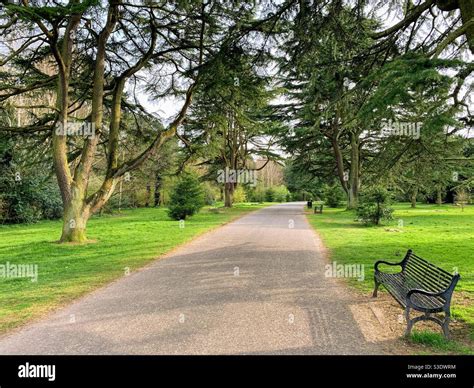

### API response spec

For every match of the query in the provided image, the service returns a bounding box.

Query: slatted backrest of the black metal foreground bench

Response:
[402,250,459,292]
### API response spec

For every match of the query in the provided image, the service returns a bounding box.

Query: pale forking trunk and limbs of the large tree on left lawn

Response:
[53,0,198,242]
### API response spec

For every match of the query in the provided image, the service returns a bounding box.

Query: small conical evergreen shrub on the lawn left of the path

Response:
[168,173,204,220]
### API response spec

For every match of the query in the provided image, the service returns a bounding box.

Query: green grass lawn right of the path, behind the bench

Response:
[308,203,474,352]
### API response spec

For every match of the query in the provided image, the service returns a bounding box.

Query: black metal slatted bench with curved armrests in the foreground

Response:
[373,249,460,338]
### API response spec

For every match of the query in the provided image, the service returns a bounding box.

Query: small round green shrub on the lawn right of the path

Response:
[357,186,393,225]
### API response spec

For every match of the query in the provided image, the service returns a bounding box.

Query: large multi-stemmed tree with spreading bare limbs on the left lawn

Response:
[0,0,250,242]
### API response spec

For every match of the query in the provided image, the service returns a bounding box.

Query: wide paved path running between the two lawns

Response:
[0,203,383,354]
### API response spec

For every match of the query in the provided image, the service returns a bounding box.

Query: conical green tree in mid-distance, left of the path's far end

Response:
[182,44,277,207]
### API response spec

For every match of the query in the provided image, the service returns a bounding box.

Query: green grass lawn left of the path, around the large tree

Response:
[0,204,268,333]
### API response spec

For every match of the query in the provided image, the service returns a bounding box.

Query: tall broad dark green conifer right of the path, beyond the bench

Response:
[272,1,473,208]
